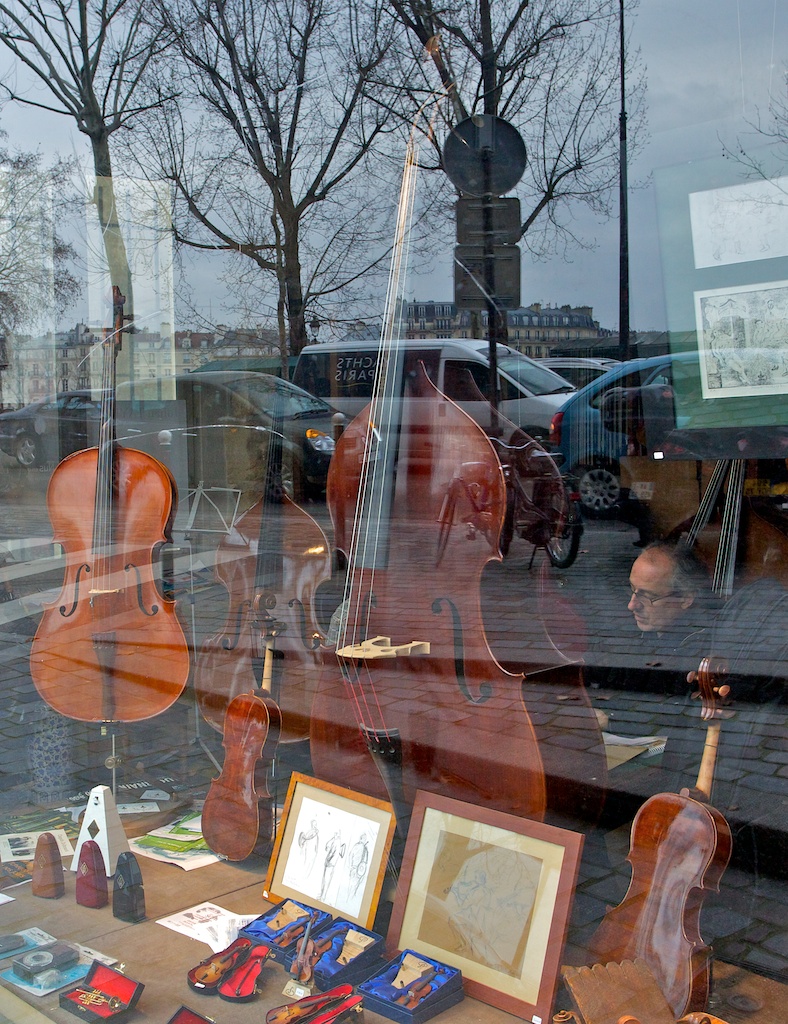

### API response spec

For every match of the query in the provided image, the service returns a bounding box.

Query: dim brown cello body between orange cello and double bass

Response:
[194,495,331,741]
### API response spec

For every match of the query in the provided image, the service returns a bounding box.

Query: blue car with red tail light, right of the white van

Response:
[550,355,679,516]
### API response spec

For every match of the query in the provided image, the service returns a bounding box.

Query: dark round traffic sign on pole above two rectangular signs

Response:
[443,114,526,197]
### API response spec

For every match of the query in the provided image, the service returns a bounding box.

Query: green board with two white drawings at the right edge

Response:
[646,148,788,459]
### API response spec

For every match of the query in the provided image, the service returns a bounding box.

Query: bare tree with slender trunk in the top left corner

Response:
[0,0,176,333]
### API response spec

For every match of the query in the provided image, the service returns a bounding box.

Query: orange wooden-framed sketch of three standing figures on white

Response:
[263,772,395,928]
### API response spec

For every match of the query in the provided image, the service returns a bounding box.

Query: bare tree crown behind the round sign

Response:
[384,0,643,256]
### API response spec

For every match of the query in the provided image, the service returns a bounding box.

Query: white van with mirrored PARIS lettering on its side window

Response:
[293,338,575,438]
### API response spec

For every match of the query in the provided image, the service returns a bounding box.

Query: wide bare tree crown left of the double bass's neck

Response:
[137,0,409,354]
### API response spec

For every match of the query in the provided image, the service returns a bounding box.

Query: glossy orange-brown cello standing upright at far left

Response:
[30,286,189,722]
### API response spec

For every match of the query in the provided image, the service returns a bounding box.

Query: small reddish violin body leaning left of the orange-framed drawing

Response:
[201,691,281,860]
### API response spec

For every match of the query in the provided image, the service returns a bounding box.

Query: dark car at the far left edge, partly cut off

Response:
[0,391,101,469]
